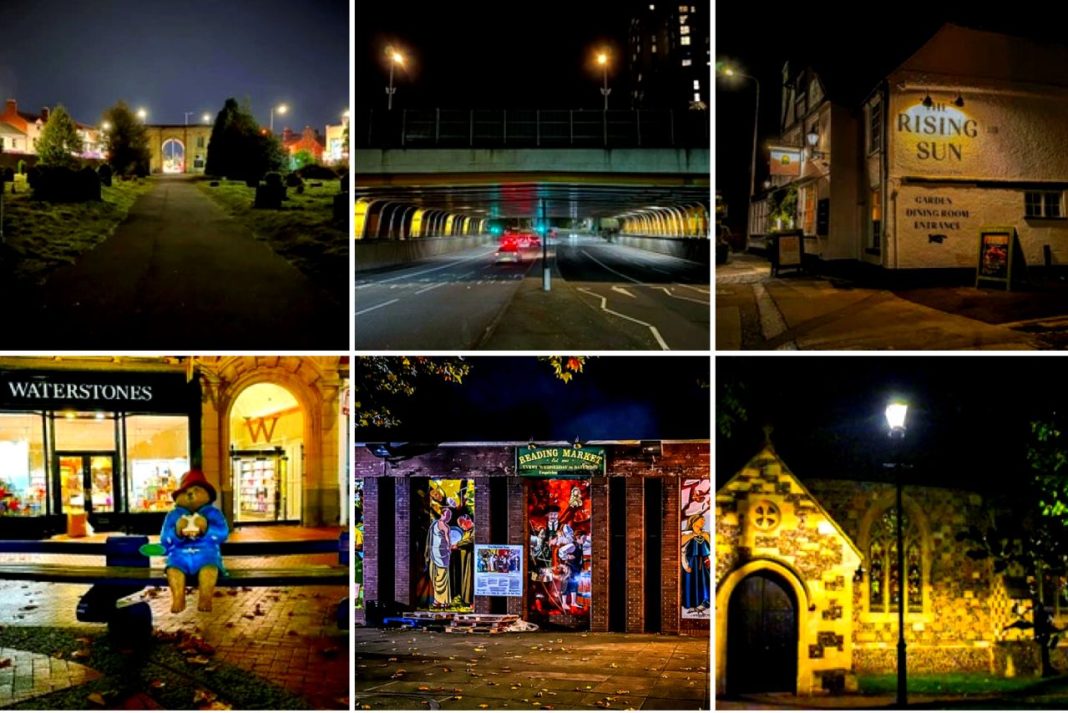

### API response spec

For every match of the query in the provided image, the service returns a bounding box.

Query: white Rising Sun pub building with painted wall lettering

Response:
[749,25,1068,279]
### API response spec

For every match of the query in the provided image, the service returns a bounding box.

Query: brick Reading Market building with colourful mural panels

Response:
[355,441,712,636]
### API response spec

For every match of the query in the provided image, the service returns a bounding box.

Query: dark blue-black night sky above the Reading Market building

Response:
[355,357,711,443]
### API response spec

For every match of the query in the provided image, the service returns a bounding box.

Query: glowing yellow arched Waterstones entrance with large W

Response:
[227,382,308,524]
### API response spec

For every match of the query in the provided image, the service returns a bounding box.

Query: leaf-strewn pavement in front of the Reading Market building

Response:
[355,627,711,710]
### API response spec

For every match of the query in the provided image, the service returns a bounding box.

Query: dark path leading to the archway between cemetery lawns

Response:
[20,177,349,351]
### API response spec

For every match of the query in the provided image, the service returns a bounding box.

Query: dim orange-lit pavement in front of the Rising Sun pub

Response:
[716,253,1068,351]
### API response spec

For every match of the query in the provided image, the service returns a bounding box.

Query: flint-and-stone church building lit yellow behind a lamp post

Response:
[714,443,1055,696]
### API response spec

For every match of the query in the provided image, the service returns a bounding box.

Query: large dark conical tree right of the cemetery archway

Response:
[205,97,285,180]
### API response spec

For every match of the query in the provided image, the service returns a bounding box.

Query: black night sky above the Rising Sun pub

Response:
[713,0,1068,234]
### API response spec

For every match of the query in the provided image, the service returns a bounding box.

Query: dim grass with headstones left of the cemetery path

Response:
[0,176,152,285]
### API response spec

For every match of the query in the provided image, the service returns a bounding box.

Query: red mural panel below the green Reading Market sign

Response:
[527,478,592,630]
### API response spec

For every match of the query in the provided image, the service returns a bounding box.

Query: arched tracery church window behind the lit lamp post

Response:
[868,508,924,614]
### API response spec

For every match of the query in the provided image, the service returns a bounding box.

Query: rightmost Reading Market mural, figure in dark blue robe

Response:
[679,478,712,619]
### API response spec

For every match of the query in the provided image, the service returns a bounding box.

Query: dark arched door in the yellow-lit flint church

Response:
[727,571,798,695]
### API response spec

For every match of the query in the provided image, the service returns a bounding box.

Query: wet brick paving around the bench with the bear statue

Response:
[0,526,350,710]
